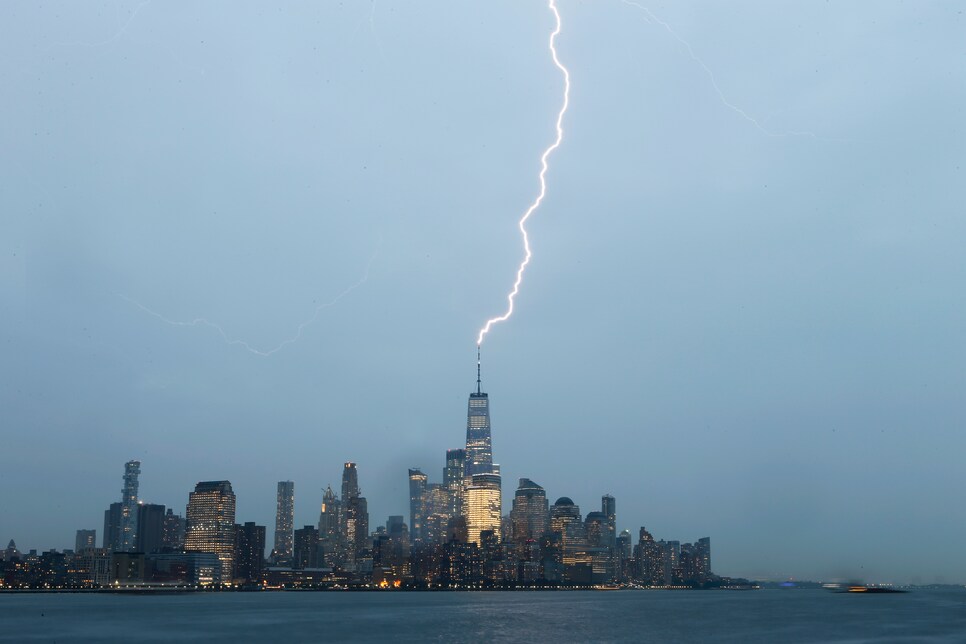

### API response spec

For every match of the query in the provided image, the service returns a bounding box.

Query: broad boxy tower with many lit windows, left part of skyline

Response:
[185,481,235,583]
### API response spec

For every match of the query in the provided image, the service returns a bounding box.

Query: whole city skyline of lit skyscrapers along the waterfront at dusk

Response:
[0,373,720,589]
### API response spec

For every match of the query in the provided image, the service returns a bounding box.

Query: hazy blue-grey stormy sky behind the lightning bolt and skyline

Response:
[0,0,966,582]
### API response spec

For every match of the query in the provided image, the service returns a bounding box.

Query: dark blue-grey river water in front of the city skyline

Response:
[0,589,966,642]
